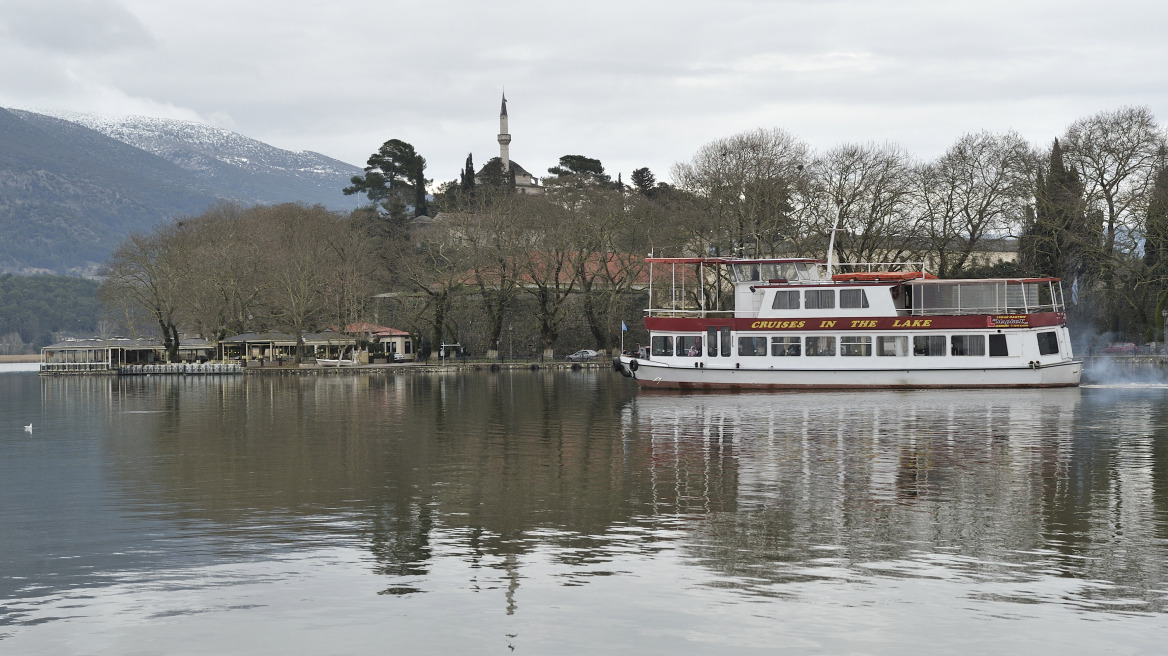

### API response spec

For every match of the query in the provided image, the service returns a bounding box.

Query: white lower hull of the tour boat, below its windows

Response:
[613,356,1083,390]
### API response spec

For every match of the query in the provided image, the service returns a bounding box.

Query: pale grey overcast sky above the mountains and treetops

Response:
[0,0,1168,183]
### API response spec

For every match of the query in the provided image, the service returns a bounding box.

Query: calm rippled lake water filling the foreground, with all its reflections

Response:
[0,367,1168,655]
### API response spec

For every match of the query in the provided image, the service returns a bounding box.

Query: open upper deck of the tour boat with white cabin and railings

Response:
[646,258,1065,319]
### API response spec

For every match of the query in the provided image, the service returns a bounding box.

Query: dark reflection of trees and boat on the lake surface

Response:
[22,371,1168,613]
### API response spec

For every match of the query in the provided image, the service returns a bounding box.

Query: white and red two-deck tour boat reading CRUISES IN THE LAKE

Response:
[613,257,1083,390]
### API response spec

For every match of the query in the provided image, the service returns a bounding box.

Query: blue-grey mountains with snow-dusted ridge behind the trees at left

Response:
[0,109,362,275]
